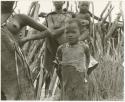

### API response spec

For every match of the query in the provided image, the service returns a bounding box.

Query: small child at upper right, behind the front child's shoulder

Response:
[76,1,91,41]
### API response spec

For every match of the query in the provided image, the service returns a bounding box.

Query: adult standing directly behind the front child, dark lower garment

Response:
[44,1,72,95]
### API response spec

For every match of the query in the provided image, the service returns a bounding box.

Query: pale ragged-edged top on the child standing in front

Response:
[61,42,86,72]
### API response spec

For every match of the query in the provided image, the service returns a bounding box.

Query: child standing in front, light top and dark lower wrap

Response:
[57,18,90,100]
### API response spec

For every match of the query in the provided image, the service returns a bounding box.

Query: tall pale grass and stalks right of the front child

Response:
[89,16,124,100]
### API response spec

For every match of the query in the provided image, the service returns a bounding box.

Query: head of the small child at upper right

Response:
[78,1,90,13]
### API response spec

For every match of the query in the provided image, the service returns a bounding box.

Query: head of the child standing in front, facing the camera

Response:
[65,18,81,45]
